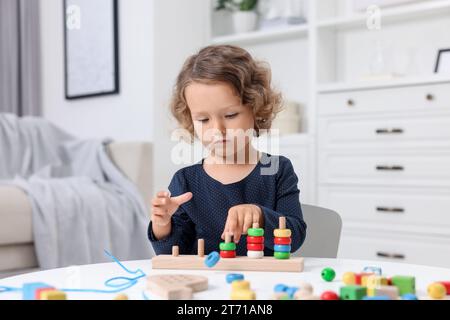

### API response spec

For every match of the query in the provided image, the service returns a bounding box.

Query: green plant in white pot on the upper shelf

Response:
[216,0,258,33]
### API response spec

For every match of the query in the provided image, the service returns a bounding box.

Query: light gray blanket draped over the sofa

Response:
[0,114,153,269]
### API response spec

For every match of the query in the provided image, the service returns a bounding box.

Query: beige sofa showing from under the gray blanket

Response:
[0,142,153,278]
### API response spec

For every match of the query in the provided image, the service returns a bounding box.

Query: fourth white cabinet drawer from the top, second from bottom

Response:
[319,187,450,236]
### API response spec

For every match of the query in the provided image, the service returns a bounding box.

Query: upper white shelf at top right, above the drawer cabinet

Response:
[317,0,450,29]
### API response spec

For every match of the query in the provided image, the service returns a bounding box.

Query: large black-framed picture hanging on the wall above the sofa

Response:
[64,0,119,99]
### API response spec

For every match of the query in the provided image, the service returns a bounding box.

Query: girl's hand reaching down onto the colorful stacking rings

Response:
[222,204,264,243]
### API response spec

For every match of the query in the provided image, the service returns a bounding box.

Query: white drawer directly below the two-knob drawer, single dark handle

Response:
[319,114,450,148]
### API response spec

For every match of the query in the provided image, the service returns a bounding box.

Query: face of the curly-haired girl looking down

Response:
[185,82,255,158]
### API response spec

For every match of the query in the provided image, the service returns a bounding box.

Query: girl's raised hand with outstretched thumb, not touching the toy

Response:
[151,191,192,226]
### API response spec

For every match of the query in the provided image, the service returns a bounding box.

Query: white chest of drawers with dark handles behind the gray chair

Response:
[318,82,450,267]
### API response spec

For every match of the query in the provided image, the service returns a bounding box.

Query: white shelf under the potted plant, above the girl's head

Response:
[212,24,308,44]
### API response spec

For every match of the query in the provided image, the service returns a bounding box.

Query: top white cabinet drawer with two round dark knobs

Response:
[318,83,450,115]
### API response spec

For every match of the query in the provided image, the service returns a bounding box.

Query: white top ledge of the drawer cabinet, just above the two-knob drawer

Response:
[317,75,450,93]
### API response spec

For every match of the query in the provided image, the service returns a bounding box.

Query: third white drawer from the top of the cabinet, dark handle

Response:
[319,150,450,187]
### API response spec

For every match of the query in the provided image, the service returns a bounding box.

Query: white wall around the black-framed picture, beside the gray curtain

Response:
[40,0,155,141]
